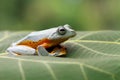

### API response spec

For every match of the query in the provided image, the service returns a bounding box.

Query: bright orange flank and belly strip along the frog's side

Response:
[17,38,68,49]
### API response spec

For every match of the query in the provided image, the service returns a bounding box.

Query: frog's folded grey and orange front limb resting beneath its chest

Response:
[38,46,66,57]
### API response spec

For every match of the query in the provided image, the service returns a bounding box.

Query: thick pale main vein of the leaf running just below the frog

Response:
[0,56,114,77]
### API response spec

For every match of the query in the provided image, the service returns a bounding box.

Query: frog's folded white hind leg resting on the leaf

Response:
[6,45,36,56]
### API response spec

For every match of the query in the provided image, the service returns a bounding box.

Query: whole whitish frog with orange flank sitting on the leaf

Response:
[7,24,76,56]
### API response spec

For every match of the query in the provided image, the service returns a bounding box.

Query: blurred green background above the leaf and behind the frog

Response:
[0,0,120,30]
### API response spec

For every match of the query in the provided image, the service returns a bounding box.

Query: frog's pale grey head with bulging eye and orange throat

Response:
[49,24,76,42]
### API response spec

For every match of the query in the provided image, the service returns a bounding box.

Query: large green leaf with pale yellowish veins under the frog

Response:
[0,31,120,80]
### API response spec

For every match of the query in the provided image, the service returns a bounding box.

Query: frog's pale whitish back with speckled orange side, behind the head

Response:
[13,29,56,48]
